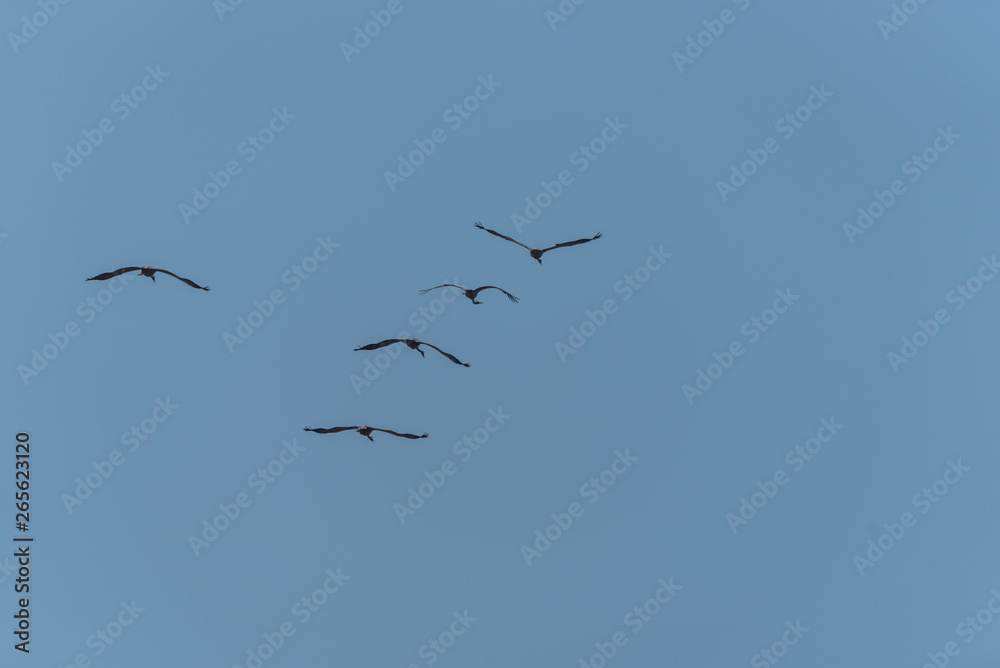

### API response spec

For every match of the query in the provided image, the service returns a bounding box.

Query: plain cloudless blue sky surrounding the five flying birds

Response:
[0,0,1000,668]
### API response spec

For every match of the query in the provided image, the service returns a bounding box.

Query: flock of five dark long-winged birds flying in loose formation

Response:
[87,222,601,443]
